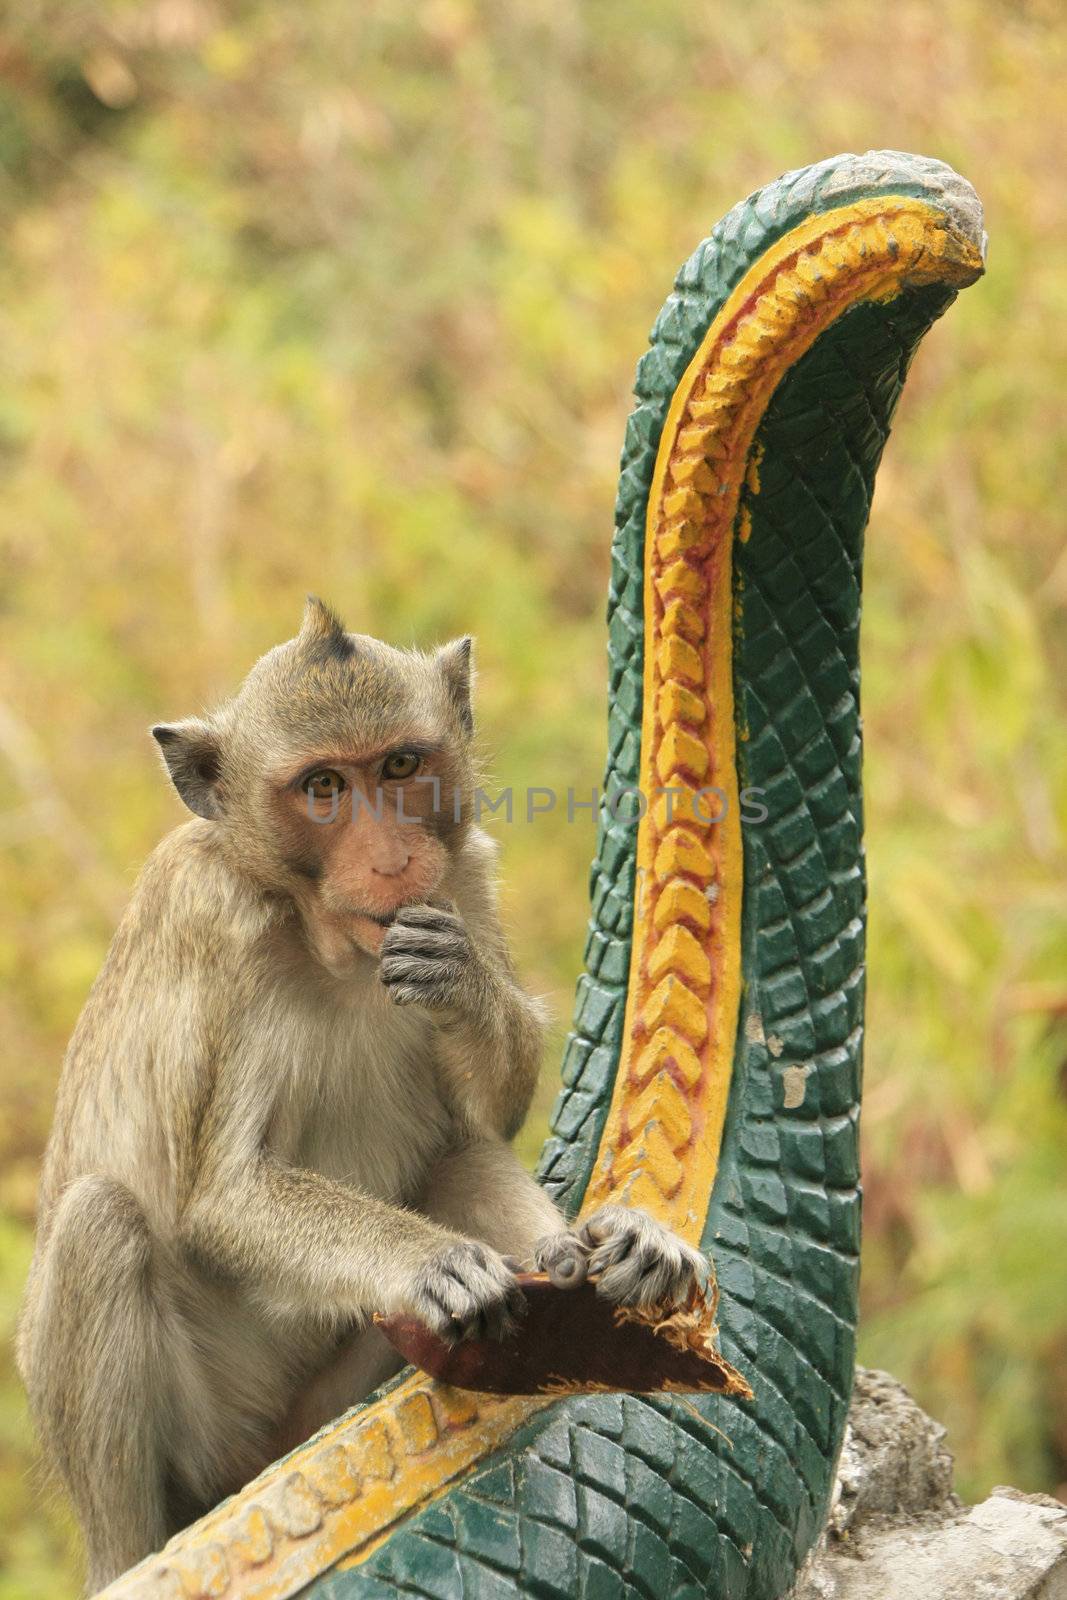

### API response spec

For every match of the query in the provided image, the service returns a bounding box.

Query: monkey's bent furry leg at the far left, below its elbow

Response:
[26,1176,170,1594]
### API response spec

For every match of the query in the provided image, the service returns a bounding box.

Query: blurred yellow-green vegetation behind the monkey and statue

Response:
[0,0,1067,1600]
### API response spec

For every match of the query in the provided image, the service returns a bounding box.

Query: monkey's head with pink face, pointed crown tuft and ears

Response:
[152,602,474,973]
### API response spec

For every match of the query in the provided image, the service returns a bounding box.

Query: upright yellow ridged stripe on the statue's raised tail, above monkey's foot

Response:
[582,195,982,1242]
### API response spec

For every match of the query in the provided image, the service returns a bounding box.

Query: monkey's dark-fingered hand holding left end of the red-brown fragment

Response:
[406,1238,525,1344]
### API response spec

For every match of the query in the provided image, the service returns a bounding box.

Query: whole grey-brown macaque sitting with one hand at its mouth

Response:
[18,600,705,1589]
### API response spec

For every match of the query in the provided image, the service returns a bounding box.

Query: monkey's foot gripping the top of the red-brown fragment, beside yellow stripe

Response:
[534,1205,709,1306]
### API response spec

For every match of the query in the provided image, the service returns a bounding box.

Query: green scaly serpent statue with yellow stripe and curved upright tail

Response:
[97,150,984,1600]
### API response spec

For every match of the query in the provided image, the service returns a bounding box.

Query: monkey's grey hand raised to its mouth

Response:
[381,906,493,1011]
